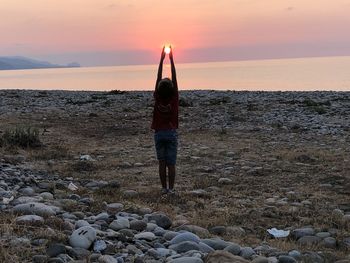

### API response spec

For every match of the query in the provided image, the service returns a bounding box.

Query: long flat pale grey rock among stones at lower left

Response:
[13,202,59,217]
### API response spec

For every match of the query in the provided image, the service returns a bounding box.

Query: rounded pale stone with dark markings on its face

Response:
[69,226,96,249]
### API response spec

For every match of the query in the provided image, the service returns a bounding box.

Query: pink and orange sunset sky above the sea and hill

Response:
[0,0,350,66]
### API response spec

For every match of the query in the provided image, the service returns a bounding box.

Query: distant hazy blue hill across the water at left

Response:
[0,57,80,70]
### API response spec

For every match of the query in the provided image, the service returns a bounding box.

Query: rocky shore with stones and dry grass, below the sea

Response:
[0,90,350,263]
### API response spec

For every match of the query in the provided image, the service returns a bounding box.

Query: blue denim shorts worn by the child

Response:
[154,130,177,165]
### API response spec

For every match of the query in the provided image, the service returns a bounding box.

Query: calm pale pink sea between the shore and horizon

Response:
[0,57,350,91]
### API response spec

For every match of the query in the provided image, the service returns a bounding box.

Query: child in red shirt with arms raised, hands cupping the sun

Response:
[152,47,179,194]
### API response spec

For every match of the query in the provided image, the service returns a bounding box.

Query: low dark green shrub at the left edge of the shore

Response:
[0,126,42,148]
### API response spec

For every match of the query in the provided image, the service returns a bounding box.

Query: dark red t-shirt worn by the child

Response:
[151,89,179,131]
